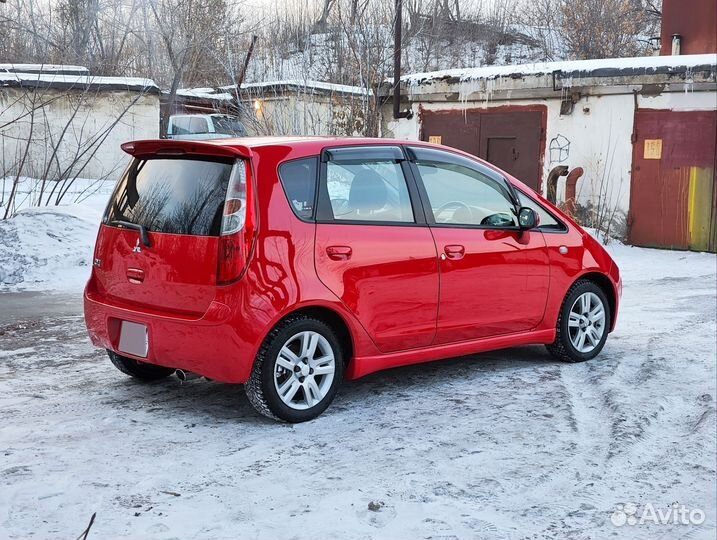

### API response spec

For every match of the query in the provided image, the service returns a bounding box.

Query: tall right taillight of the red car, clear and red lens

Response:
[217,160,254,285]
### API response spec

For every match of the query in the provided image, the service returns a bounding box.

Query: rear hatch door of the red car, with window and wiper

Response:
[94,156,237,315]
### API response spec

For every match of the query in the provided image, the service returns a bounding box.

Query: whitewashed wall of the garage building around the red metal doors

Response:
[381,87,717,235]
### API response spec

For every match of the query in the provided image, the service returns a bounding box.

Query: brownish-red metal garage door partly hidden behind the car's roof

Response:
[421,105,547,190]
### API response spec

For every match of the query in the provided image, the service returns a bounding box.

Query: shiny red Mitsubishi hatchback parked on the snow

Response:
[84,138,621,422]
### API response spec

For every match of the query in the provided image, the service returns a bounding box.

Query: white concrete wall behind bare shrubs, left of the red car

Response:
[0,87,159,179]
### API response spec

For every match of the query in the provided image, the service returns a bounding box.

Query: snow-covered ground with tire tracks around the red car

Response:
[0,200,717,540]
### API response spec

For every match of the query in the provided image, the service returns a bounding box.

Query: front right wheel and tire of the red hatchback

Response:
[546,279,611,362]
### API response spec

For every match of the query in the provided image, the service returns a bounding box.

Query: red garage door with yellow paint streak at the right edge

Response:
[629,110,717,251]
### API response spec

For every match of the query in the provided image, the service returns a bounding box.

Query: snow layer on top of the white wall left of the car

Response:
[0,71,159,93]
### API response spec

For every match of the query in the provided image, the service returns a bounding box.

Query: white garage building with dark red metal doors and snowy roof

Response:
[381,54,717,251]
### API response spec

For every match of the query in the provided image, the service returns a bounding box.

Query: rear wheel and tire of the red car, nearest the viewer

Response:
[244,315,344,423]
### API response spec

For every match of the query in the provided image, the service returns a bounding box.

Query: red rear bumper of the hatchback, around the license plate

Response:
[84,285,253,383]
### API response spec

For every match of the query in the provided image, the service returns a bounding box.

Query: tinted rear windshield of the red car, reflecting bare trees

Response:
[105,159,232,236]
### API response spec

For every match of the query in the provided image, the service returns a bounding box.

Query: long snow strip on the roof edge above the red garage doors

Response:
[400,54,717,85]
